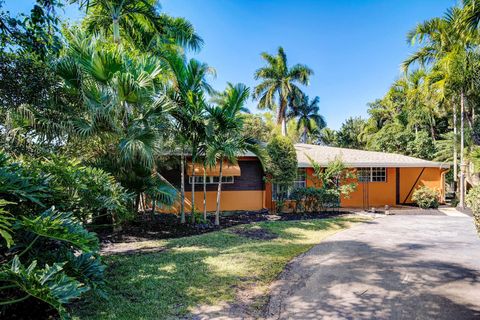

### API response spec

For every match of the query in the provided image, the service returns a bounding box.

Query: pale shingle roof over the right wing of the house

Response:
[295,143,450,169]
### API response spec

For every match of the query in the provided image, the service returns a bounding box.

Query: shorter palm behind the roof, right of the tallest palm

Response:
[287,94,327,143]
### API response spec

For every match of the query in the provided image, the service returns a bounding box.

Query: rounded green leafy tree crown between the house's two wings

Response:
[265,136,298,186]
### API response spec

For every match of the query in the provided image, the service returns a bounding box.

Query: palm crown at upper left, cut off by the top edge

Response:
[77,0,203,51]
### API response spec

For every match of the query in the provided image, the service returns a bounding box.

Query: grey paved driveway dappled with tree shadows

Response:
[267,216,480,319]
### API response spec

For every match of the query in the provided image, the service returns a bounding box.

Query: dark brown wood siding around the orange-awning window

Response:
[162,159,265,191]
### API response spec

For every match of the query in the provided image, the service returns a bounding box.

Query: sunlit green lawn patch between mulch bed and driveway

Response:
[74,218,359,320]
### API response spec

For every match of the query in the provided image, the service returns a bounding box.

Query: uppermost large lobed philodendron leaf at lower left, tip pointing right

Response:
[21,207,99,251]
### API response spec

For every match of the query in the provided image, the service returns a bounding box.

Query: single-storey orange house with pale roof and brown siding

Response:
[162,144,449,211]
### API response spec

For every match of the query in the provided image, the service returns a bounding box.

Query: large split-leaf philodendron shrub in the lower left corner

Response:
[0,152,105,318]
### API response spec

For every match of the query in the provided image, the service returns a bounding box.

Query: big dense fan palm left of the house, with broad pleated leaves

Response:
[56,32,175,211]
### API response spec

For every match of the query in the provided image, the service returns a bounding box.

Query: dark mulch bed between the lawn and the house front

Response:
[97,210,350,243]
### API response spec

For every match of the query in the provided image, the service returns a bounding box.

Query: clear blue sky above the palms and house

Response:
[5,0,456,129]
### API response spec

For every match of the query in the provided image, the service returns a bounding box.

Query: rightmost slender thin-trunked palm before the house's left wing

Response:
[207,83,263,225]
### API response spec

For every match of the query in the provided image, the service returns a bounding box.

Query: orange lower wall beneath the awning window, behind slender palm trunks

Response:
[160,190,271,213]
